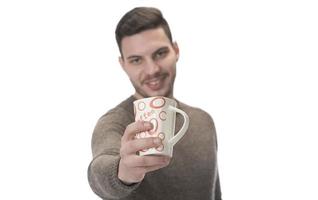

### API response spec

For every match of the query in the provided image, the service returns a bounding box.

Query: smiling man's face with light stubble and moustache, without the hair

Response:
[119,28,179,99]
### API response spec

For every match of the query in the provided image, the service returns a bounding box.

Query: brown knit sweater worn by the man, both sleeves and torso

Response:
[88,96,221,200]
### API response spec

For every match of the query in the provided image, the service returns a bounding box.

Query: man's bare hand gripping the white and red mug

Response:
[118,121,170,184]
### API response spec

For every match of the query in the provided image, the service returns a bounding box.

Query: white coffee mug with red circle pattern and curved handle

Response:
[134,96,189,157]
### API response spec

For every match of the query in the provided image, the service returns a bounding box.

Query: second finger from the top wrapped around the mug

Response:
[120,137,162,156]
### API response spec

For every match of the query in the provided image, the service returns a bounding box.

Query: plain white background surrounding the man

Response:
[0,0,318,200]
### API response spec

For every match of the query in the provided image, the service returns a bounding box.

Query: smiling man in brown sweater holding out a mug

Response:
[88,7,221,200]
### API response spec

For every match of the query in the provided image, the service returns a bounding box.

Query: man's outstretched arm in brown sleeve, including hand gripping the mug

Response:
[88,108,170,199]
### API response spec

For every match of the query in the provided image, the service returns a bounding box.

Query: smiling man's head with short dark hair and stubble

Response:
[116,7,179,98]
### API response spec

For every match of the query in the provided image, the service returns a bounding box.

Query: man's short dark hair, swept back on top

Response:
[115,7,172,54]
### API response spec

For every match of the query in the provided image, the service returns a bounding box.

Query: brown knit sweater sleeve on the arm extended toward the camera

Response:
[88,108,139,200]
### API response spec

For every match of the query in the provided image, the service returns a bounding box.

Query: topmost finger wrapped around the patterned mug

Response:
[122,121,152,142]
